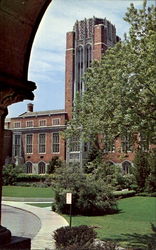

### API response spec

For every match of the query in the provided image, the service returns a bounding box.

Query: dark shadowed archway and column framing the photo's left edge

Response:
[0,0,52,246]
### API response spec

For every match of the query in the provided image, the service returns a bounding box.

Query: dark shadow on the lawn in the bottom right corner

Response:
[103,233,156,250]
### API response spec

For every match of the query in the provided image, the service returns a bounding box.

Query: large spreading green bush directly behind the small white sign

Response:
[55,165,117,215]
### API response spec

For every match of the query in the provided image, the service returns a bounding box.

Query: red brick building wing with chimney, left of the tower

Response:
[5,103,66,174]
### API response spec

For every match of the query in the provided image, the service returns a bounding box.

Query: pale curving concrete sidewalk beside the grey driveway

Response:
[2,201,68,250]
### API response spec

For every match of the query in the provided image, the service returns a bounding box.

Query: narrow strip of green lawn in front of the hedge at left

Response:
[2,186,54,198]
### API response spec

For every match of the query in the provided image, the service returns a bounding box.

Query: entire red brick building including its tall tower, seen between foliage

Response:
[5,17,149,173]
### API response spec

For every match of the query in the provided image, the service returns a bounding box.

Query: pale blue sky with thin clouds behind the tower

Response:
[8,0,154,117]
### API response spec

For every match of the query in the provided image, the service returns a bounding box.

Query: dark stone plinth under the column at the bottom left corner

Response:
[0,236,31,250]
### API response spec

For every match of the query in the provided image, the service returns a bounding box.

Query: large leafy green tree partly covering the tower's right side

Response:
[69,1,156,144]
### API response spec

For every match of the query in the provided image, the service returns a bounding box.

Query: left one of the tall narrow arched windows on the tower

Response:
[77,46,83,92]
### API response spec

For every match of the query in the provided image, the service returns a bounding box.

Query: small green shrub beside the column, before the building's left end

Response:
[2,164,22,185]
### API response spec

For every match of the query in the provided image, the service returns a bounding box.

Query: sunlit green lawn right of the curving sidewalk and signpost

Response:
[64,197,156,246]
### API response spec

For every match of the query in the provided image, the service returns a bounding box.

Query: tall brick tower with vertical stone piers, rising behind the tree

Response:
[65,17,119,120]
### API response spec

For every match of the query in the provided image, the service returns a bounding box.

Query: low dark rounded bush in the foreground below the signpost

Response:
[53,225,96,250]
